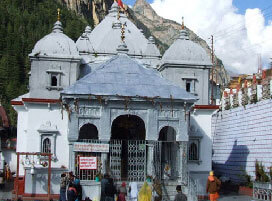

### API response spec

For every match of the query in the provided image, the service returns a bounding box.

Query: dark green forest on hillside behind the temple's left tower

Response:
[0,0,92,126]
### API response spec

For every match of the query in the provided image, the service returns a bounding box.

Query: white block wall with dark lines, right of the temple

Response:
[212,99,272,182]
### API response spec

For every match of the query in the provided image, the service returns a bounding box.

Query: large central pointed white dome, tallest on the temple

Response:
[89,2,151,55]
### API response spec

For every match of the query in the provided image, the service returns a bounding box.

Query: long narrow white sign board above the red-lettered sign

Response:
[74,142,110,153]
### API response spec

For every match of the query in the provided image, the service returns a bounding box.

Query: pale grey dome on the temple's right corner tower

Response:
[162,29,212,66]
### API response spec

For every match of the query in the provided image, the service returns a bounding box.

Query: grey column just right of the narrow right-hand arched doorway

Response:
[178,141,188,185]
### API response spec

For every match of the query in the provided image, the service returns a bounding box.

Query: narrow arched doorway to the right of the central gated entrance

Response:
[159,126,178,179]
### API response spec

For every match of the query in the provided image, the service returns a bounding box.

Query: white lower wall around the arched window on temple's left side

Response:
[17,104,69,175]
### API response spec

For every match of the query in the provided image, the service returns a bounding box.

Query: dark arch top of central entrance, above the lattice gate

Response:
[111,114,146,140]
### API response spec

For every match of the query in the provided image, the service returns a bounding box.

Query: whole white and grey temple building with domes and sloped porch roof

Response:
[12,2,218,200]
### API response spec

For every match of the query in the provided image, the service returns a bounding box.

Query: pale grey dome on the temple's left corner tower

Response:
[30,21,79,57]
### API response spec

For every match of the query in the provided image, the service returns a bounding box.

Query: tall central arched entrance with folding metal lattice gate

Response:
[111,115,146,181]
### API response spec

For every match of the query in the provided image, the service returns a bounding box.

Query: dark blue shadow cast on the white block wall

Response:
[213,139,249,183]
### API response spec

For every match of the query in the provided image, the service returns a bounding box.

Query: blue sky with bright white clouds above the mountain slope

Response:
[123,0,272,73]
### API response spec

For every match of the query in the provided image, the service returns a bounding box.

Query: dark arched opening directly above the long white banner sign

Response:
[78,123,98,140]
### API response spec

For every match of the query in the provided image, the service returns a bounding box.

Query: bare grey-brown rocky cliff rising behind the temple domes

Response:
[58,0,229,85]
